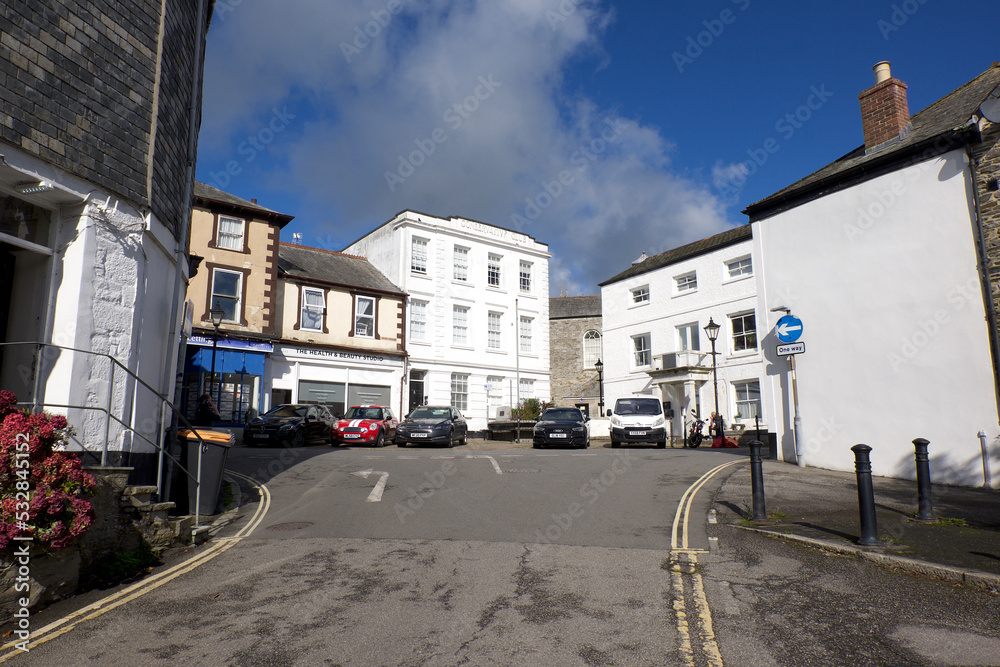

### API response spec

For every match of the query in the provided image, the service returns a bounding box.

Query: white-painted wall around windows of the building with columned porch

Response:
[601,232,760,436]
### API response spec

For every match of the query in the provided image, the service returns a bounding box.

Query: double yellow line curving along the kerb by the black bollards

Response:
[670,461,744,667]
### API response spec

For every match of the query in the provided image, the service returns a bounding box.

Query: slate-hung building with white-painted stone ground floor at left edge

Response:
[0,0,213,483]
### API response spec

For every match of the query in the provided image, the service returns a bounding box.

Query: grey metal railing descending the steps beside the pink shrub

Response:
[0,341,213,531]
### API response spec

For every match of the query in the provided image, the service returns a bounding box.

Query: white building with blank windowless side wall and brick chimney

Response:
[748,63,1000,486]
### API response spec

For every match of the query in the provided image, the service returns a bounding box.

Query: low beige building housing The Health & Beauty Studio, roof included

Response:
[265,243,406,416]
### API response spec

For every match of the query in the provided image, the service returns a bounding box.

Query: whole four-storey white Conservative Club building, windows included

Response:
[344,211,551,431]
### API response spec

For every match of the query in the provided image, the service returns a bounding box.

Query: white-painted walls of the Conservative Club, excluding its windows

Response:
[344,211,551,430]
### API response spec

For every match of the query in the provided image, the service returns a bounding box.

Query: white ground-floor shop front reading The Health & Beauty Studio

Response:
[268,345,405,417]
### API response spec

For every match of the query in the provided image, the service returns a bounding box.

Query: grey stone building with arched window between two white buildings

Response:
[549,294,604,417]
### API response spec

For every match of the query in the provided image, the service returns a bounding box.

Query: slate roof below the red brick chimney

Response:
[743,62,1000,220]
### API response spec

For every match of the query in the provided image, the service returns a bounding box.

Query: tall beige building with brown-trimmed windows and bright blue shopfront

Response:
[181,182,292,424]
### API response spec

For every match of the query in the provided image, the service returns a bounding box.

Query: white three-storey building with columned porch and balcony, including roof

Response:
[601,226,770,438]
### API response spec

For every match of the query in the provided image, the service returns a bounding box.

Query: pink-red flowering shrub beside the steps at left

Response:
[0,391,95,553]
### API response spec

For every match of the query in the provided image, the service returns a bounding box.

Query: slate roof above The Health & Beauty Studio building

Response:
[278,243,406,296]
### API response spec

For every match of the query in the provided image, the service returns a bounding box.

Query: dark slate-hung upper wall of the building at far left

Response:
[0,0,212,238]
